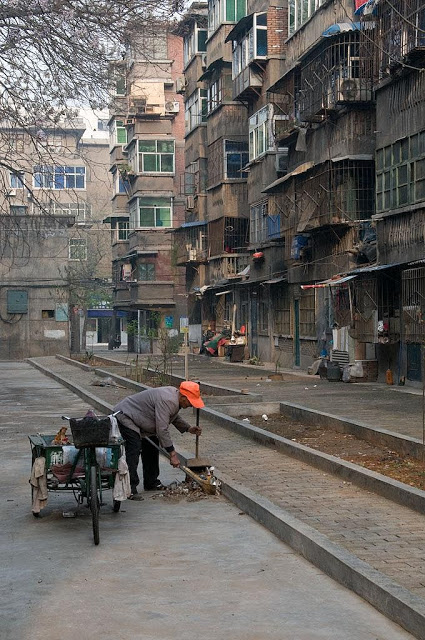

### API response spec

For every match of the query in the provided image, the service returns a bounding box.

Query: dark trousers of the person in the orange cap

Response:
[118,422,159,493]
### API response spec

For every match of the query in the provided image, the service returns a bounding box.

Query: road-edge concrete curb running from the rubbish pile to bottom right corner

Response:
[216,470,425,640]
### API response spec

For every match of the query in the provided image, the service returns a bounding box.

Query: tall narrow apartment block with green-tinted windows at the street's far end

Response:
[107,25,187,351]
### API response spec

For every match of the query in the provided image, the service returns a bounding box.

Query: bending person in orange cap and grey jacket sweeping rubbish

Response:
[113,381,204,500]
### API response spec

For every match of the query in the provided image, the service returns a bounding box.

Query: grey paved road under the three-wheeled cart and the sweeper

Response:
[0,362,412,640]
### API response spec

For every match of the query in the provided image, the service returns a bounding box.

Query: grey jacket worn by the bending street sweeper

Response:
[114,387,190,451]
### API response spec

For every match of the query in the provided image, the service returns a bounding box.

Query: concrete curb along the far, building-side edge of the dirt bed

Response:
[280,402,423,459]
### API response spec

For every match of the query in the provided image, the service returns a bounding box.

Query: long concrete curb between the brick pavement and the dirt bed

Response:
[201,407,425,514]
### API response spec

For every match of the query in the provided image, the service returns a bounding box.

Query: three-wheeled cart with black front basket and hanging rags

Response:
[28,416,124,544]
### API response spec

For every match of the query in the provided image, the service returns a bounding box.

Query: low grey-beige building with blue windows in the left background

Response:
[0,118,110,359]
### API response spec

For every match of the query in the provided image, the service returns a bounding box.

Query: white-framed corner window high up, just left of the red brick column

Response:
[232,13,267,78]
